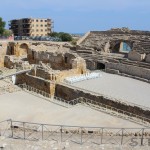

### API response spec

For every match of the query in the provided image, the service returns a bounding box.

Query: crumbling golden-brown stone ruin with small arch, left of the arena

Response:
[0,42,87,95]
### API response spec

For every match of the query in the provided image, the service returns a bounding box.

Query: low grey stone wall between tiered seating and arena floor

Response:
[105,62,150,80]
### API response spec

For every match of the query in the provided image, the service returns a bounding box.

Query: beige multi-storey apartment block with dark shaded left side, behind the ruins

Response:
[9,18,53,36]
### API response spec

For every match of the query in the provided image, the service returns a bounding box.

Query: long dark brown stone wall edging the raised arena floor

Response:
[55,84,150,118]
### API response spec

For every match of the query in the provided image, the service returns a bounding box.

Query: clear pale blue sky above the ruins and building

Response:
[0,0,150,33]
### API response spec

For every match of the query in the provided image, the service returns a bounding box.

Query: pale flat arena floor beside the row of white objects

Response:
[73,72,150,107]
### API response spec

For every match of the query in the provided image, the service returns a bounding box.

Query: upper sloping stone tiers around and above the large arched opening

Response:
[79,29,150,54]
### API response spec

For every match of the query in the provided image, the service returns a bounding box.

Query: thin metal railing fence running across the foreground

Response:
[0,119,150,147]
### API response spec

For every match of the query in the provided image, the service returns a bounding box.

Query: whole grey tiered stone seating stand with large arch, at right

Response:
[76,28,150,82]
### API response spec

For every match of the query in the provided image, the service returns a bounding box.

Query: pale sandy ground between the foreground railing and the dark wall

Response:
[0,91,141,128]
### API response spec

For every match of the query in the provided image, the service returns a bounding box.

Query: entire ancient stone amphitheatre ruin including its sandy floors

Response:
[0,28,150,150]
